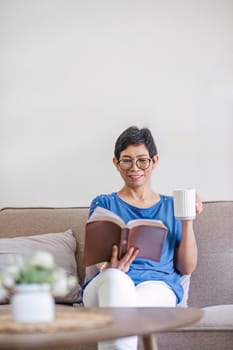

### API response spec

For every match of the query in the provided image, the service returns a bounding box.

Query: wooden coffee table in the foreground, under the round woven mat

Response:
[0,305,203,350]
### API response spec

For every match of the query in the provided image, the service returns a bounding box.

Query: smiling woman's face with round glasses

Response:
[113,144,158,188]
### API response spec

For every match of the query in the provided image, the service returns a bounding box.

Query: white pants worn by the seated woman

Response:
[83,269,176,350]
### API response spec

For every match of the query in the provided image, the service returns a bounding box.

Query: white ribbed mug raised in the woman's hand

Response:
[173,189,196,220]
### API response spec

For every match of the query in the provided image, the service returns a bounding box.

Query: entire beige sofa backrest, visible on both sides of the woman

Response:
[0,201,233,307]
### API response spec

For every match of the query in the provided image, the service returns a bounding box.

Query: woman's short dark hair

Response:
[114,126,158,160]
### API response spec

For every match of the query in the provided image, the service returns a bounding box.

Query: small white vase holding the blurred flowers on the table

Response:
[11,284,55,323]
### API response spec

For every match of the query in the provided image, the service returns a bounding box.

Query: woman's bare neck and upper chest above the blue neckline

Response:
[117,186,160,208]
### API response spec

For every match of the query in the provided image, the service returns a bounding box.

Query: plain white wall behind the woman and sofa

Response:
[0,0,233,207]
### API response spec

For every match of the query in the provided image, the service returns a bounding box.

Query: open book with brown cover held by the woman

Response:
[84,207,168,266]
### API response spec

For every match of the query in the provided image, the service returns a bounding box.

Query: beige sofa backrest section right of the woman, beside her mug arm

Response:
[189,201,233,307]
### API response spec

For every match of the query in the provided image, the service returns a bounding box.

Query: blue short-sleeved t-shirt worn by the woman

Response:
[83,192,183,303]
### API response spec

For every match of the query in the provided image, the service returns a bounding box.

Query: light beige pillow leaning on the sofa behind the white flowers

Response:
[0,230,81,304]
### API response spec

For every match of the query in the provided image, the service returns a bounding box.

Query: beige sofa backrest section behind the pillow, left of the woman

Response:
[0,207,89,282]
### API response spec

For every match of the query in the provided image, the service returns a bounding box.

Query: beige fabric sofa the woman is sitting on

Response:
[0,201,233,350]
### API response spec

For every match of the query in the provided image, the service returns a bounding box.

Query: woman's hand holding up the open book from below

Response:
[107,245,139,272]
